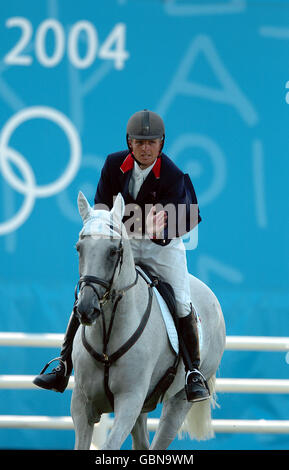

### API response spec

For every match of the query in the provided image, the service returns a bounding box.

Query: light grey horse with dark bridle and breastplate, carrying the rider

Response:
[71,193,225,450]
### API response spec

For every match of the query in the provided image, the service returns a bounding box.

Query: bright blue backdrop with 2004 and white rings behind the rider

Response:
[0,0,289,449]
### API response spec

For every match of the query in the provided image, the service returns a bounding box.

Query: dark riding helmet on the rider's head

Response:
[126,109,165,153]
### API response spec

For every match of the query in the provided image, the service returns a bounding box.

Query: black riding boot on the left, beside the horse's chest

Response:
[33,310,79,393]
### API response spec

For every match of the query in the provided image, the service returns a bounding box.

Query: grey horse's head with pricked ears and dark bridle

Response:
[76,192,125,325]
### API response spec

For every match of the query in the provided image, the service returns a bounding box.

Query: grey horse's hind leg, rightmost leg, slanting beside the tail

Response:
[150,390,192,450]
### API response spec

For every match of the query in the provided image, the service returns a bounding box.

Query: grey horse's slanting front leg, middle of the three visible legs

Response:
[102,390,145,450]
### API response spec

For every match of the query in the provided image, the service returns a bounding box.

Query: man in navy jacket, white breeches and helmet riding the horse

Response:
[33,110,210,402]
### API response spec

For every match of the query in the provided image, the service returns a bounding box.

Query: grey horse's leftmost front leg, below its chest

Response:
[71,387,94,450]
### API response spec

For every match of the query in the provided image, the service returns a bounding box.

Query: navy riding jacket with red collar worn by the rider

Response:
[94,150,201,246]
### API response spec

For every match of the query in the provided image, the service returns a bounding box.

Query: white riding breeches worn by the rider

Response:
[130,238,191,317]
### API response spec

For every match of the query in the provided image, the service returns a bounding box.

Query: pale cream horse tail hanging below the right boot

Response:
[178,375,218,441]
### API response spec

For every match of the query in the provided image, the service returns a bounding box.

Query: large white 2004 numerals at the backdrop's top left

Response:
[3,16,129,70]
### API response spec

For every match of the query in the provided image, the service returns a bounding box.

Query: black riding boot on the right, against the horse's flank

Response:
[178,309,210,402]
